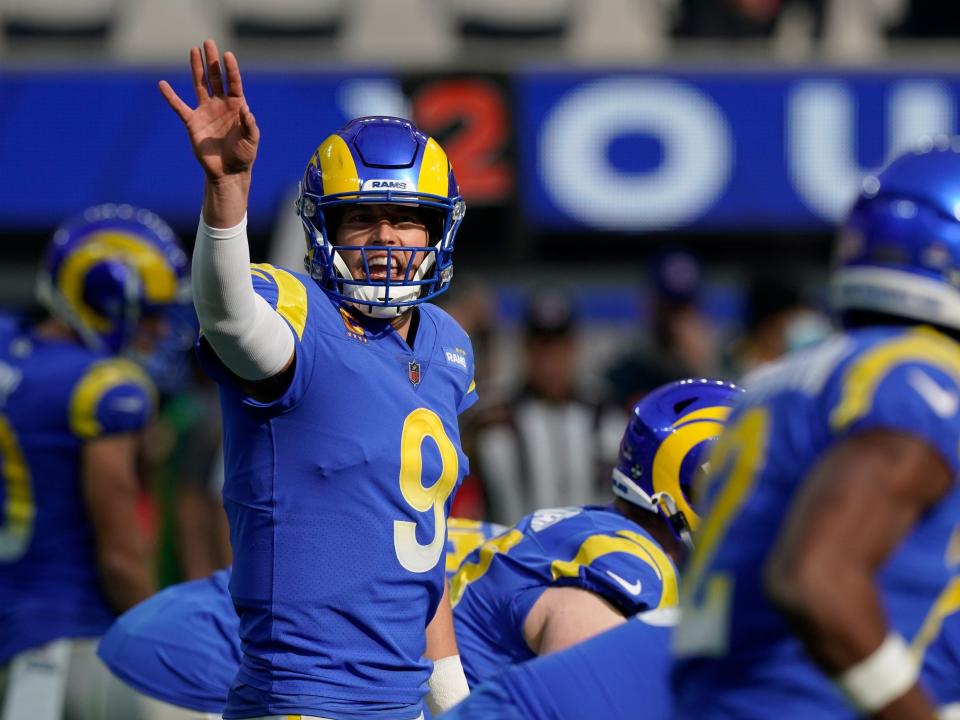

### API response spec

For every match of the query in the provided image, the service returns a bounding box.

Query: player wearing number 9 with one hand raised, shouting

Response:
[161,40,476,720]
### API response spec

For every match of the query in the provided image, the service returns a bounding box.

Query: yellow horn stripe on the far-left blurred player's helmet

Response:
[57,231,177,332]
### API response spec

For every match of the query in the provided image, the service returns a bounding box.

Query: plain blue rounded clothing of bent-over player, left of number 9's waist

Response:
[97,569,240,715]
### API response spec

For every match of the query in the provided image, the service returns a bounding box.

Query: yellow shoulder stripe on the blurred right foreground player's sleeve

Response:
[830,327,960,430]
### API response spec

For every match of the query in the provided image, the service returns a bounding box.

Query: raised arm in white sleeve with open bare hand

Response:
[160,40,294,400]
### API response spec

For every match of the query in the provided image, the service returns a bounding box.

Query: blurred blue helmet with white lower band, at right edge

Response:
[831,138,960,329]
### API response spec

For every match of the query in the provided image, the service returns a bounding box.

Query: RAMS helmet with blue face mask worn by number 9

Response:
[297,117,466,317]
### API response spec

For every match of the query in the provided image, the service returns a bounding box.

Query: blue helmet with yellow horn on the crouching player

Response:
[613,378,742,547]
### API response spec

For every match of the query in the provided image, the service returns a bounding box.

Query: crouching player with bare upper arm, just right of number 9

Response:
[451,379,738,686]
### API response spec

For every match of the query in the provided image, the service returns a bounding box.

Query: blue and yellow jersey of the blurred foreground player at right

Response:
[673,328,960,720]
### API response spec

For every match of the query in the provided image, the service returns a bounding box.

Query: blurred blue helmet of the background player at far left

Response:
[37,204,190,355]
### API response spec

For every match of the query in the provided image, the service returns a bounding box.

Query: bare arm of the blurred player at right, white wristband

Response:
[765,430,952,720]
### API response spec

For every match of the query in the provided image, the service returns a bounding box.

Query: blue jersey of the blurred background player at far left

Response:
[0,318,154,663]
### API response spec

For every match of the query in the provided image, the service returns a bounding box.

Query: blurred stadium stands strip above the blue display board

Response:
[0,0,960,67]
